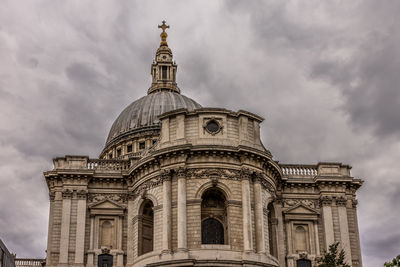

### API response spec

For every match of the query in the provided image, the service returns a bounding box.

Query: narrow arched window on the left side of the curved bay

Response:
[138,199,154,255]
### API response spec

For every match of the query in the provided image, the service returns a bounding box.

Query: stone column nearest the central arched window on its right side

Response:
[241,169,253,252]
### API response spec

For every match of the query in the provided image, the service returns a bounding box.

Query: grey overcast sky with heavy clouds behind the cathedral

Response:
[0,0,400,267]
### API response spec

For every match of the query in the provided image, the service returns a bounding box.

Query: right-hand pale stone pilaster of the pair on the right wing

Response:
[336,197,352,265]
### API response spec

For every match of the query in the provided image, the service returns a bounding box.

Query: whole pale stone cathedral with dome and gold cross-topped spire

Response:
[44,21,362,267]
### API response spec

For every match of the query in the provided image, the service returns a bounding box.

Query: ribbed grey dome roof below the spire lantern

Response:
[106,91,201,147]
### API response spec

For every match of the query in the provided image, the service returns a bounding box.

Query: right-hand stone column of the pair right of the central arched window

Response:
[254,175,268,253]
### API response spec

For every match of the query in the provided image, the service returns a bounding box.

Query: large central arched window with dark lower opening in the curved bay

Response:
[201,188,228,244]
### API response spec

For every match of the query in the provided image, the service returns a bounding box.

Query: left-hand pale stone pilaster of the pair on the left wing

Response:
[59,189,72,266]
